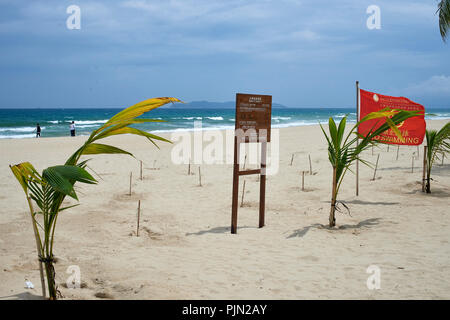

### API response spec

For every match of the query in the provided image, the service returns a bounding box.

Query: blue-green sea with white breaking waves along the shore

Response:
[0,107,450,139]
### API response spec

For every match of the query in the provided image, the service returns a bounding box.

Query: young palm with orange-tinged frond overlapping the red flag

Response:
[320,109,418,227]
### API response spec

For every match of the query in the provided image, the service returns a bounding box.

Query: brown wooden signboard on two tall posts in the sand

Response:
[231,93,272,233]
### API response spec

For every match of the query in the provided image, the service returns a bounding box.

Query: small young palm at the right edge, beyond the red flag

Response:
[425,122,450,193]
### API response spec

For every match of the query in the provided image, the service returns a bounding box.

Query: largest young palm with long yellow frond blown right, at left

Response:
[10,98,181,300]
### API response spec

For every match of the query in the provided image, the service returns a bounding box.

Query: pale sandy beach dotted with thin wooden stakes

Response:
[0,120,450,299]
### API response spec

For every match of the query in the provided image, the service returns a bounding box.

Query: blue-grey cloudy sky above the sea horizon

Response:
[0,0,450,108]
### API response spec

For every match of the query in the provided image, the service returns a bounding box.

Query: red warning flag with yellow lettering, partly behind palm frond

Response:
[358,89,426,146]
